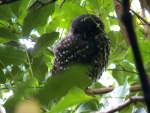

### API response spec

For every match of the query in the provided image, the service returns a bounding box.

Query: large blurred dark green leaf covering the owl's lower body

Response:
[36,65,92,105]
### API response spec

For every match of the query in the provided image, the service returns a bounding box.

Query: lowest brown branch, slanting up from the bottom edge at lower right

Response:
[95,96,144,113]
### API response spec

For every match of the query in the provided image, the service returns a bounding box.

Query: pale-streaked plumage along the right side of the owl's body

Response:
[90,34,110,81]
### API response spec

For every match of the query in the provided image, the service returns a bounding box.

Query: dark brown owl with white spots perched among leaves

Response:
[52,14,110,82]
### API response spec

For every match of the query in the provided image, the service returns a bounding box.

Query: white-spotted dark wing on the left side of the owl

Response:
[53,35,96,73]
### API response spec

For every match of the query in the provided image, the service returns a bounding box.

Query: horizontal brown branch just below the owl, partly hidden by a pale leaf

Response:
[85,85,142,95]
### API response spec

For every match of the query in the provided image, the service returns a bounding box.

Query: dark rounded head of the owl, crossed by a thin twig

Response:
[71,14,104,35]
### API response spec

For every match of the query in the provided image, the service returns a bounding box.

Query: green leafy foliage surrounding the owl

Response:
[0,0,150,113]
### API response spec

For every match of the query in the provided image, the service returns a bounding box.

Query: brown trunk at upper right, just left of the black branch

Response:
[113,0,130,47]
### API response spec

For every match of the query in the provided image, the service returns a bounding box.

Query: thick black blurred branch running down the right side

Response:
[122,0,150,113]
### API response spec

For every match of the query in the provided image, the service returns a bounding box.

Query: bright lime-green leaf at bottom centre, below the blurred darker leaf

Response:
[49,87,93,113]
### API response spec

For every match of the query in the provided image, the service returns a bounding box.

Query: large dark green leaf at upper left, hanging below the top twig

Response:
[22,4,54,36]
